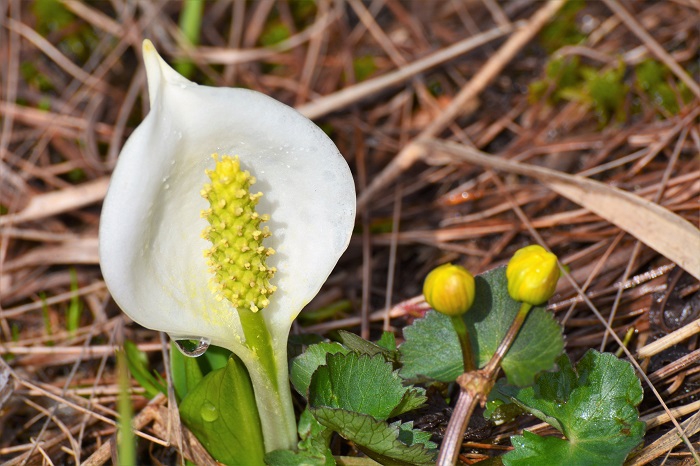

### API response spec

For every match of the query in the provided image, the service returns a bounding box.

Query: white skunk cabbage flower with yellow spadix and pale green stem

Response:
[99,40,355,451]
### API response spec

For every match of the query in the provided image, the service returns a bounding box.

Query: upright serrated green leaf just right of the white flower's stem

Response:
[309,352,408,420]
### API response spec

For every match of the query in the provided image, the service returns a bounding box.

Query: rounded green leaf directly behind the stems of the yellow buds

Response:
[399,267,564,386]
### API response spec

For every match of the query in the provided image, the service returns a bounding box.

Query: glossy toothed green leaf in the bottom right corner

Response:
[496,350,645,466]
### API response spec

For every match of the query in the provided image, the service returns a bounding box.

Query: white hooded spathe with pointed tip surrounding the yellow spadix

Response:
[100,41,355,349]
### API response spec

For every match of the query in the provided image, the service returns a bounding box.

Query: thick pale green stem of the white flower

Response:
[231,310,297,452]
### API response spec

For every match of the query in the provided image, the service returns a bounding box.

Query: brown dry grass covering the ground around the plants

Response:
[0,0,700,465]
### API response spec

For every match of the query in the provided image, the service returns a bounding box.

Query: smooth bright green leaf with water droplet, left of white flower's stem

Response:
[180,356,265,466]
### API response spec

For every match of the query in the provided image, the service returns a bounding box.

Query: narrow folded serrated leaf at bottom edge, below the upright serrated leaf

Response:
[311,408,435,466]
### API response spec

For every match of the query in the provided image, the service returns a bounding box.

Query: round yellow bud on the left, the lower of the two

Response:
[423,264,475,316]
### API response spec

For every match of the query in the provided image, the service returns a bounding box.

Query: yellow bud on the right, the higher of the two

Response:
[506,244,560,306]
